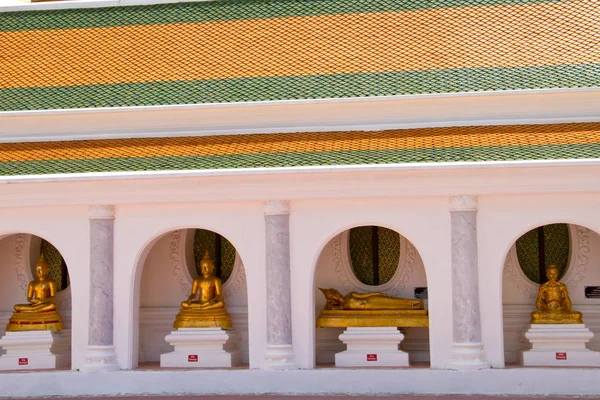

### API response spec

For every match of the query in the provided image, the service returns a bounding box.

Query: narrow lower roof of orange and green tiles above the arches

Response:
[0,123,600,176]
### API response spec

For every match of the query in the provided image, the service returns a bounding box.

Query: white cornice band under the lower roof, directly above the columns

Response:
[0,160,600,207]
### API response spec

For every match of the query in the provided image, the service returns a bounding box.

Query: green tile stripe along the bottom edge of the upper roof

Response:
[0,64,600,111]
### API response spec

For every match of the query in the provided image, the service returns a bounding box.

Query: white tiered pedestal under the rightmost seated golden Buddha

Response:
[519,324,600,367]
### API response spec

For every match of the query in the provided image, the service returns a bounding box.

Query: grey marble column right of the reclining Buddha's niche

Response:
[447,196,490,370]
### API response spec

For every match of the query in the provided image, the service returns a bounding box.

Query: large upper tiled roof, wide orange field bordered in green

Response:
[0,0,600,110]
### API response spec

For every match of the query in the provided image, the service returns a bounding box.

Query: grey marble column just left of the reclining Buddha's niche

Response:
[264,201,297,369]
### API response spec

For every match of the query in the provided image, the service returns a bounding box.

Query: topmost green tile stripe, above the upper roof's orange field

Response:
[0,0,574,32]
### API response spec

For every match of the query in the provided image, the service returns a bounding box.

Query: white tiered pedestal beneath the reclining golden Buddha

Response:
[335,327,408,367]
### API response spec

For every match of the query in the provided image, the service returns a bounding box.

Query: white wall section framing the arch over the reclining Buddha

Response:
[290,197,452,368]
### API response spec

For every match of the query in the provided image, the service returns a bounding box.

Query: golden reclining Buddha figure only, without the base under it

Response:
[319,288,424,310]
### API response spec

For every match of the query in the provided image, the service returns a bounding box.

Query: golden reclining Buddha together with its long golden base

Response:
[317,288,429,328]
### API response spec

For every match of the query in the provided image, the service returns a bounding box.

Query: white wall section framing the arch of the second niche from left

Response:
[115,202,266,369]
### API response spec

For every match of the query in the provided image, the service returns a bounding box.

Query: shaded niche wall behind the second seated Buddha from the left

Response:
[138,229,249,363]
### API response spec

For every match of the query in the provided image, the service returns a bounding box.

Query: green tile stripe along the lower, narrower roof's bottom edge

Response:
[0,143,600,176]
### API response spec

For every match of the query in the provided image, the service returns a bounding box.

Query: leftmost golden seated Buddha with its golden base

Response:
[6,254,63,332]
